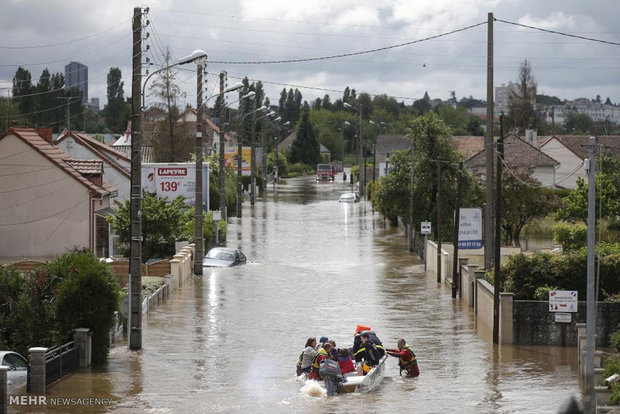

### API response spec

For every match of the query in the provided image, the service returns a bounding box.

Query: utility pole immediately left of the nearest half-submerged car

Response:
[194,62,204,276]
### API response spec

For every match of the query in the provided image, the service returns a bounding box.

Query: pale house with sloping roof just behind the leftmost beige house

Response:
[54,130,131,203]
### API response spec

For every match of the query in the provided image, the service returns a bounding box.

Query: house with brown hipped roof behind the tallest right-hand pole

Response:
[465,134,559,187]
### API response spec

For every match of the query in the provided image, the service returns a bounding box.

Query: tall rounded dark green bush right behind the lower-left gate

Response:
[46,250,120,362]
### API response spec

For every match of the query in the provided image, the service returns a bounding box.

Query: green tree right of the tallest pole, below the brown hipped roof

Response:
[501,169,560,246]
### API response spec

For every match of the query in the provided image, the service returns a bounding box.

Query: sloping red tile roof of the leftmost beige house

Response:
[0,127,108,195]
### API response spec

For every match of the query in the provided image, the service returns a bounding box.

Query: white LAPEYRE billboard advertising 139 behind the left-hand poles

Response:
[142,163,209,206]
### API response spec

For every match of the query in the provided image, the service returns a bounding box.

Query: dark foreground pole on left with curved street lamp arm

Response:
[127,47,207,349]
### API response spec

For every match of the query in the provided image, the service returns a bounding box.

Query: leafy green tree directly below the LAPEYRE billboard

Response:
[108,192,187,262]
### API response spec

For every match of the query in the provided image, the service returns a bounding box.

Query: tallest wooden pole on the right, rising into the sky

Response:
[484,13,494,270]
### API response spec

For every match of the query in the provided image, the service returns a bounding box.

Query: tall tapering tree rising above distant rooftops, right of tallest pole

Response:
[508,59,537,133]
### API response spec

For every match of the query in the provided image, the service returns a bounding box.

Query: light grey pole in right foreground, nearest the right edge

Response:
[585,137,596,414]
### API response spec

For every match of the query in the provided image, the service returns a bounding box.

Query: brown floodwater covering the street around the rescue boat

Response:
[38,178,580,413]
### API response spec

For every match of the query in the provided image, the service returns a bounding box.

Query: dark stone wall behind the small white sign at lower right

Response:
[513,300,620,347]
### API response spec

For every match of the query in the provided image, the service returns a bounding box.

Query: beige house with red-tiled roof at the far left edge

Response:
[0,127,116,263]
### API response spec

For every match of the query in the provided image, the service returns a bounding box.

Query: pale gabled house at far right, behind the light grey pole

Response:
[539,135,620,189]
